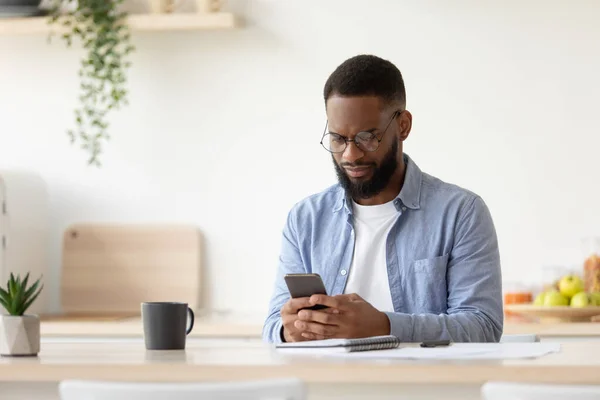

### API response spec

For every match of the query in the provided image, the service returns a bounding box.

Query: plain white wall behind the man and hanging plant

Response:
[0,0,600,314]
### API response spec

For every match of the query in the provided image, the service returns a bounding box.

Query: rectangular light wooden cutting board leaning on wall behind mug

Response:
[61,224,201,319]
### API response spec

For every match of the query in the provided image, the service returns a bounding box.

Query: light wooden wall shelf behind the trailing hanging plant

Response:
[0,12,238,35]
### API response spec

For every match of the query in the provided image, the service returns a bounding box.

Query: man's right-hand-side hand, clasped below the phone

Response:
[292,294,390,340]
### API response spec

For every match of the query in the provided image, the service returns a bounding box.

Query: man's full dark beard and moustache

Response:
[332,138,398,199]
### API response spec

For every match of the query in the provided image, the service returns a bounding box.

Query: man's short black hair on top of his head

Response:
[323,54,406,108]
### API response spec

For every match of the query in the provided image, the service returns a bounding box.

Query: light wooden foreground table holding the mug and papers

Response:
[0,339,600,399]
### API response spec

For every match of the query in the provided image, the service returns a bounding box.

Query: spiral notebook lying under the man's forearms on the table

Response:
[275,335,400,352]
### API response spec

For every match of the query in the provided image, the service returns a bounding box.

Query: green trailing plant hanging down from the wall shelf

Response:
[49,0,135,166]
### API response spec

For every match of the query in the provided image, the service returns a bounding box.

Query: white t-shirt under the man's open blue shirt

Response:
[344,201,399,312]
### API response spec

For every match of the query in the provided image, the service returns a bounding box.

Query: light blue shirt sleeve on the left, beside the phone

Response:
[262,209,306,343]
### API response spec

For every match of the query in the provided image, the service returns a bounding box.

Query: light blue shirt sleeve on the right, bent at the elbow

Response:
[386,196,504,342]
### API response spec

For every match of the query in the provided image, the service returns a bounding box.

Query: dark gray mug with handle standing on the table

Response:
[142,302,194,350]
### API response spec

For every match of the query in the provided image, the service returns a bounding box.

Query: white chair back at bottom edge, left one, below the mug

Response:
[59,379,307,400]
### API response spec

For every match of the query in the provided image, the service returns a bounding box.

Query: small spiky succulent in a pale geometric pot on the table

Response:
[0,273,44,356]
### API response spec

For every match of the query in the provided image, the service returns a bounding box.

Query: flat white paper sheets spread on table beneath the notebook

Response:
[278,342,560,360]
